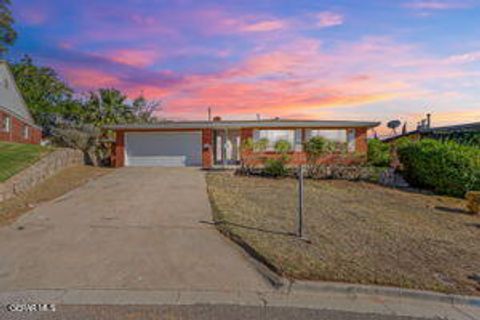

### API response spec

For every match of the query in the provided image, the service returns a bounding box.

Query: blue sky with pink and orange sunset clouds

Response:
[10,0,480,129]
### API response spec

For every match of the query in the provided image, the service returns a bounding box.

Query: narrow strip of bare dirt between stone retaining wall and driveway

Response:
[0,166,112,226]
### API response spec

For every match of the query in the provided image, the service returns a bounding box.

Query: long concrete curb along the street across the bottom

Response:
[0,286,480,320]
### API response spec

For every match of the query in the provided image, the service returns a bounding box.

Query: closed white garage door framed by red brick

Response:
[125,131,202,167]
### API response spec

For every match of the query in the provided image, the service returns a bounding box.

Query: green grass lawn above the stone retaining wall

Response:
[0,141,51,182]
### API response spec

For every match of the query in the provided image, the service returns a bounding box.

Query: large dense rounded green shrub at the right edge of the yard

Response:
[397,139,480,197]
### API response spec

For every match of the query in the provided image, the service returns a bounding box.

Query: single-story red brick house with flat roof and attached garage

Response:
[105,118,380,169]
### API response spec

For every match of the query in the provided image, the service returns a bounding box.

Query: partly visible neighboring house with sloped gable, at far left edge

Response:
[0,61,42,144]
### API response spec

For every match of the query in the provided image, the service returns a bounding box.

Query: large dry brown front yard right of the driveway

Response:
[207,173,480,295]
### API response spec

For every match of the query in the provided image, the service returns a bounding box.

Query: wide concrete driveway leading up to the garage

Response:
[0,168,269,291]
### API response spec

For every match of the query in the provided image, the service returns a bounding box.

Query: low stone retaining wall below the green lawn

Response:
[0,149,84,202]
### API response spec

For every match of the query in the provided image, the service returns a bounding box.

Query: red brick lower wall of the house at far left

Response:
[0,110,42,144]
